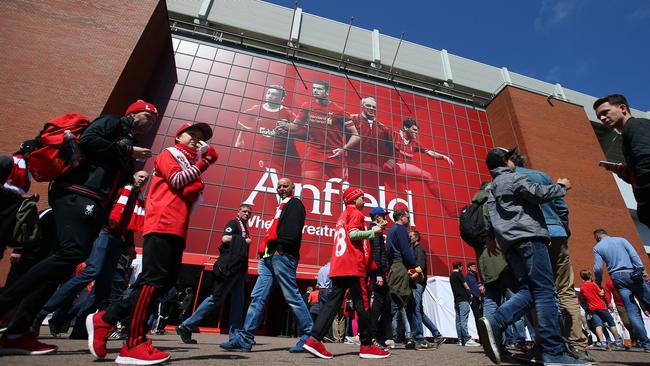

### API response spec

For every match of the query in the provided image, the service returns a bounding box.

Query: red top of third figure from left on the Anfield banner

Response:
[348,114,393,166]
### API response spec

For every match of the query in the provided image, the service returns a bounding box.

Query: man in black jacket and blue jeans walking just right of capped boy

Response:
[176,204,251,344]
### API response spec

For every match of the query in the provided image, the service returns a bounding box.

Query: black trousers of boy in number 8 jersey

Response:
[311,276,375,346]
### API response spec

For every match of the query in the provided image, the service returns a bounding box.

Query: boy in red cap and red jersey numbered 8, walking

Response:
[303,187,390,358]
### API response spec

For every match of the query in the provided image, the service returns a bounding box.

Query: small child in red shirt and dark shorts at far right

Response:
[580,269,626,349]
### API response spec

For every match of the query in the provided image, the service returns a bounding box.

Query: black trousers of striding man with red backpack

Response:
[0,189,108,334]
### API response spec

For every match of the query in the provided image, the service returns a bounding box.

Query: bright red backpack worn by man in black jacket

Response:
[27,113,90,182]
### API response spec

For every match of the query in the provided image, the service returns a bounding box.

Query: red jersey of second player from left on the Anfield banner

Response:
[298,99,352,163]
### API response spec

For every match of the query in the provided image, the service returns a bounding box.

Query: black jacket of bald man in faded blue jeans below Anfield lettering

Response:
[267,197,307,258]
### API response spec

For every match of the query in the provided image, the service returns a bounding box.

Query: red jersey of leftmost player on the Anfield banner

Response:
[240,105,298,156]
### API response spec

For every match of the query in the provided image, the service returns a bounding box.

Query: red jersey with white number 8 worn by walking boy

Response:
[330,205,366,277]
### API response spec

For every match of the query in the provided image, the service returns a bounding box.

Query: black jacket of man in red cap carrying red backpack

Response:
[54,115,133,205]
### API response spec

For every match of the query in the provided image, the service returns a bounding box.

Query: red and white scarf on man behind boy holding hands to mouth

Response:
[108,184,144,235]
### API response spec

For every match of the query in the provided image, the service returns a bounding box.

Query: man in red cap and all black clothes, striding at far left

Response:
[0,100,158,355]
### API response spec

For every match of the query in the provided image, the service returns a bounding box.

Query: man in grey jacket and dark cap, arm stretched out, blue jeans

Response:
[477,148,590,365]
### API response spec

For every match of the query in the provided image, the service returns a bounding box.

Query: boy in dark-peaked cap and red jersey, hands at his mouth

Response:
[86,123,218,365]
